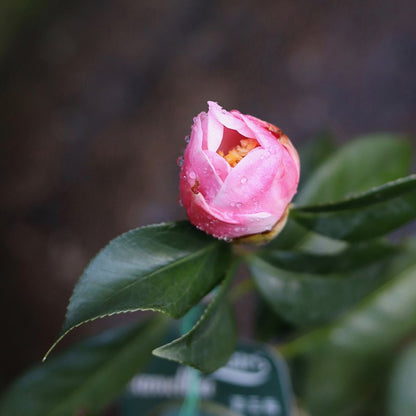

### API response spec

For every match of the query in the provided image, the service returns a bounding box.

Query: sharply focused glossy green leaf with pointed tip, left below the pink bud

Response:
[52,221,230,360]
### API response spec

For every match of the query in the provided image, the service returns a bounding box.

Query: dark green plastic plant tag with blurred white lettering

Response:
[120,344,293,416]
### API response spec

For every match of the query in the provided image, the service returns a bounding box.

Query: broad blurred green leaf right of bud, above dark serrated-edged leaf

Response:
[296,134,412,205]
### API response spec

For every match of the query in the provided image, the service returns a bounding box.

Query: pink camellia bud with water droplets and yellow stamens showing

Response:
[180,101,300,241]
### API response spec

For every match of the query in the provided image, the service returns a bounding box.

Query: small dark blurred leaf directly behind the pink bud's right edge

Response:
[295,132,336,194]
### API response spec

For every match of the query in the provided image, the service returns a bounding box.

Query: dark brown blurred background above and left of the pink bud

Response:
[0,0,416,396]
